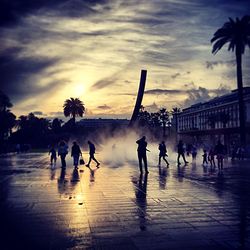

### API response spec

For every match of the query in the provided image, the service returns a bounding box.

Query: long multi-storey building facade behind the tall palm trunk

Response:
[177,87,250,144]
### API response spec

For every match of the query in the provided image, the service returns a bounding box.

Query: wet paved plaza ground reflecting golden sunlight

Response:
[0,153,250,250]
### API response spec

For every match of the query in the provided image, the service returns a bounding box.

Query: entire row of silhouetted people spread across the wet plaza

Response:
[16,136,245,174]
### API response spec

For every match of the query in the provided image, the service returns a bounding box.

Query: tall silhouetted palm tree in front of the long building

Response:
[211,15,250,145]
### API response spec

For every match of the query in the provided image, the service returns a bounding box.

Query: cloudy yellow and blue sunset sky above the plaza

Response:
[0,0,250,118]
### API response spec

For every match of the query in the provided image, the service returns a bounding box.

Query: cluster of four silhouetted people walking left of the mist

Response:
[49,140,100,169]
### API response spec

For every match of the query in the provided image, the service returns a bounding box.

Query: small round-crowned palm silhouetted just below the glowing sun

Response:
[63,97,85,123]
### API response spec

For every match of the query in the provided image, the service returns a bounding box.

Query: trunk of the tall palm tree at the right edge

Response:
[236,46,246,146]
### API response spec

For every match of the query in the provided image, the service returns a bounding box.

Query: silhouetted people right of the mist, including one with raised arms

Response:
[136,136,228,174]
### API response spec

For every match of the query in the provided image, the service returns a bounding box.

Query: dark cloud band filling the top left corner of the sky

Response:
[0,0,106,26]
